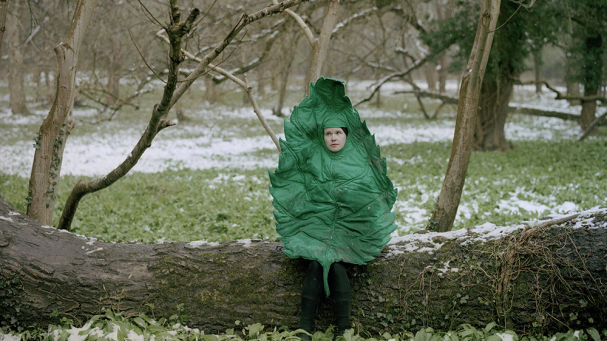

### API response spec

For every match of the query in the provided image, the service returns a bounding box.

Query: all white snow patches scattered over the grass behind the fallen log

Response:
[0,82,607,236]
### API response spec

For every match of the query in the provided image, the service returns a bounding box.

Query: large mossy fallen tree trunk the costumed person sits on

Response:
[0,195,607,333]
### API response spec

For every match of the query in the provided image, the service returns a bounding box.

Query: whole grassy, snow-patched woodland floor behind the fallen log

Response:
[0,82,607,241]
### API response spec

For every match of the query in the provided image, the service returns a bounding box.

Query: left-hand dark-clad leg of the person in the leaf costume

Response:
[299,260,324,340]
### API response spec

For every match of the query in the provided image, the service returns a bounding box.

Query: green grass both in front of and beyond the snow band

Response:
[0,79,607,242]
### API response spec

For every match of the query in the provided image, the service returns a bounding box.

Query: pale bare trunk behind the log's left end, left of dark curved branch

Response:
[27,0,97,225]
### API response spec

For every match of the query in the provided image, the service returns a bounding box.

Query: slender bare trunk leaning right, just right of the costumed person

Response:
[427,0,500,232]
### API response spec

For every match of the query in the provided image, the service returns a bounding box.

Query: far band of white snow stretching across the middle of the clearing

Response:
[0,99,579,177]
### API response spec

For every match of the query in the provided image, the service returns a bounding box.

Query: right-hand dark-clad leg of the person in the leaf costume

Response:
[329,262,352,335]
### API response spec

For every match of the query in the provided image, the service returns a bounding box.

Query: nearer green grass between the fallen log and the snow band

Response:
[0,140,607,242]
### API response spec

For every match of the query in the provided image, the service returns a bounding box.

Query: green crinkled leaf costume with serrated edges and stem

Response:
[270,77,396,296]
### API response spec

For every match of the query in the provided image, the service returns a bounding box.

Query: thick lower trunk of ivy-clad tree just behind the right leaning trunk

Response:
[473,76,514,151]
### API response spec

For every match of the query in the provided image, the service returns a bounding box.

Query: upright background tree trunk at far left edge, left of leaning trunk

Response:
[7,2,30,115]
